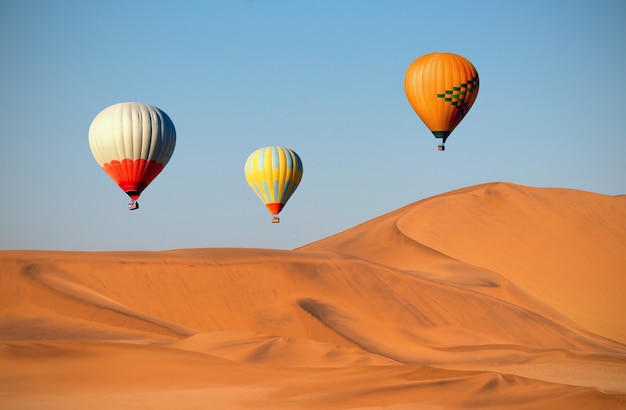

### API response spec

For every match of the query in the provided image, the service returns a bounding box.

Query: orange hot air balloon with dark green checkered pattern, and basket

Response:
[404,53,479,151]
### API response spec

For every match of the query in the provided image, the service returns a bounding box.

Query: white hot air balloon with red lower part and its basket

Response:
[89,102,176,210]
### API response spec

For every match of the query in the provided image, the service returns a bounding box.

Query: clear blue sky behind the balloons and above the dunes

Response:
[0,0,626,250]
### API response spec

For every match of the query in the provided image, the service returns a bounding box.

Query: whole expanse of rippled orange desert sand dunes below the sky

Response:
[0,183,626,410]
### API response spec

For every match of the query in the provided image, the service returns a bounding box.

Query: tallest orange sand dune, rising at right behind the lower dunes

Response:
[302,183,626,344]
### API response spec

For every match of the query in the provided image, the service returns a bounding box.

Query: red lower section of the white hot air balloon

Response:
[102,159,165,200]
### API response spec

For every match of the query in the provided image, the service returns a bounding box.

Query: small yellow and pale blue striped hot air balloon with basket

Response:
[245,147,302,223]
